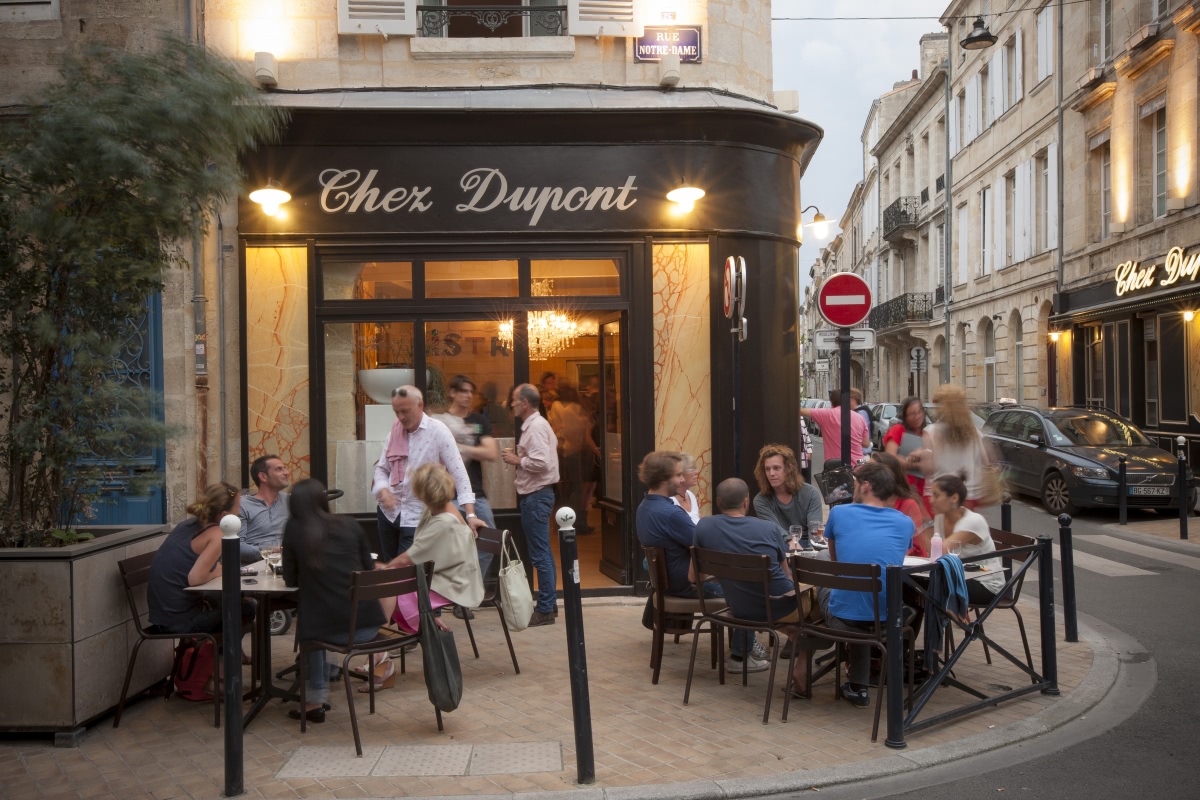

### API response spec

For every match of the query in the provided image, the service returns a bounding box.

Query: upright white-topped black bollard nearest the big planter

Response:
[221,513,245,798]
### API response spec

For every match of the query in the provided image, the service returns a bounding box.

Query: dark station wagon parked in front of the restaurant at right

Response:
[983,405,1194,515]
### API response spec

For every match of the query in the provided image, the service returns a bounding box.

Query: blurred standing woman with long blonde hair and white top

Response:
[908,384,990,510]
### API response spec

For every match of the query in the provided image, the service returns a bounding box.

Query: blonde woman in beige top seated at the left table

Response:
[359,463,484,692]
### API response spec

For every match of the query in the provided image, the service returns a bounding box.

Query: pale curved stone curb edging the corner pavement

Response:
[388,607,1154,800]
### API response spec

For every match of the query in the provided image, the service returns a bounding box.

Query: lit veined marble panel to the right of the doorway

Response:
[653,242,713,513]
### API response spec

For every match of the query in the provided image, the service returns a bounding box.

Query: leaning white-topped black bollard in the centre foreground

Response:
[554,506,596,783]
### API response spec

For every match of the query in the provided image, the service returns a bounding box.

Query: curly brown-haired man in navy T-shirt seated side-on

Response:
[636,451,763,672]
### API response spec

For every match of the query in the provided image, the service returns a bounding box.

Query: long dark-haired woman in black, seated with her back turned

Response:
[282,479,385,722]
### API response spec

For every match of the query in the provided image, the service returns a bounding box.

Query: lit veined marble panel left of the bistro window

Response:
[246,247,312,482]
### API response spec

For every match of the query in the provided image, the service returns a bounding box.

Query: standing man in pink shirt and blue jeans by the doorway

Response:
[500,384,558,627]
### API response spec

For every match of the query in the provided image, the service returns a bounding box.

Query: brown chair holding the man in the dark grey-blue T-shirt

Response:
[683,547,781,724]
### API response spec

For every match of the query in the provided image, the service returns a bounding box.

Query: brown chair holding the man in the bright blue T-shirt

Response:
[784,555,914,741]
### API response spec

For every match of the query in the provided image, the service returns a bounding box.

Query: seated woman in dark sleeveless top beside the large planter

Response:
[146,482,256,633]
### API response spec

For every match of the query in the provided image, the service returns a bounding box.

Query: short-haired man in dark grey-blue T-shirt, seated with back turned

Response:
[692,477,797,672]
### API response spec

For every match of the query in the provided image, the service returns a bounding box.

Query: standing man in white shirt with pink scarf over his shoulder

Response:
[371,386,484,564]
